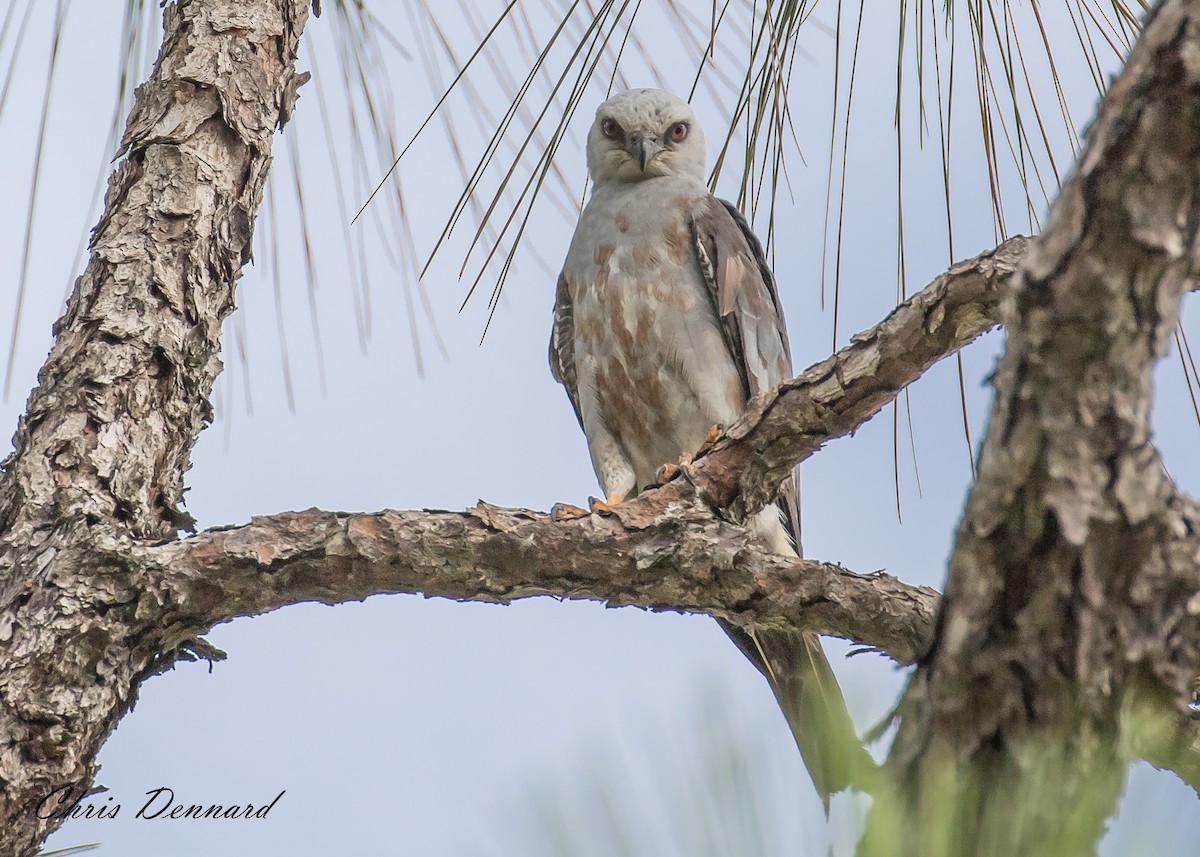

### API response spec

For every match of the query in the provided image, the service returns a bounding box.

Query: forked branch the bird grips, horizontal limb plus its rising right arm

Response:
[119,238,1028,664]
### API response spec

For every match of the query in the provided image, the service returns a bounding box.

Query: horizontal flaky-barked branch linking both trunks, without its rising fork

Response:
[125,503,938,664]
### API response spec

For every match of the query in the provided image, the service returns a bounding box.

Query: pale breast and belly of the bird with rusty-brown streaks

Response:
[563,177,743,487]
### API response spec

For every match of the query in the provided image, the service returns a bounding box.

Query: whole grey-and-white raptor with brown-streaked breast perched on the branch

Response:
[550,89,870,808]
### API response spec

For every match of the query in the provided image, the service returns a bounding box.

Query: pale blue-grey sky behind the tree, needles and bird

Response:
[0,2,1200,857]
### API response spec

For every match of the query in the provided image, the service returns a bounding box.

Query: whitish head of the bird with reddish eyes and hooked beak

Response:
[588,89,704,187]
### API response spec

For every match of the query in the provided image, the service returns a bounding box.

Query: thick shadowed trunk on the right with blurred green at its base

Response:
[864,0,1200,857]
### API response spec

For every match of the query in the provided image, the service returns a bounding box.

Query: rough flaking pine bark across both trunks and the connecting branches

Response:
[0,0,1200,857]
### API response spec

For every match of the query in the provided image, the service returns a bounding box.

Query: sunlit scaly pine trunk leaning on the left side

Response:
[0,0,307,857]
